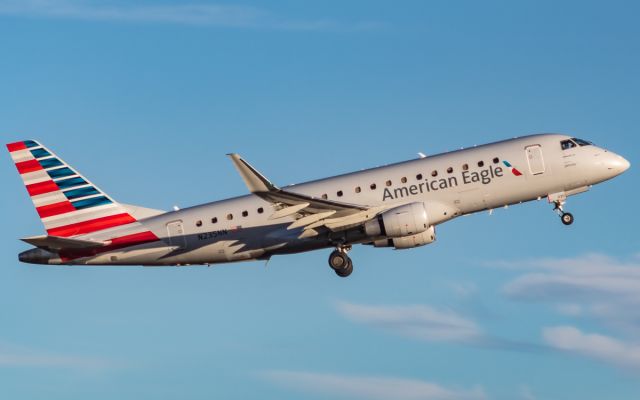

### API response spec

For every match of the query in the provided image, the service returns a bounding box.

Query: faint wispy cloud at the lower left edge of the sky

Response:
[0,343,108,369]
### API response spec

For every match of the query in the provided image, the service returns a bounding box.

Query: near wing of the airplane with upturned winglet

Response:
[229,153,386,238]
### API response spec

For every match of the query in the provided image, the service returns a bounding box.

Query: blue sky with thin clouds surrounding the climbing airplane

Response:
[0,0,640,400]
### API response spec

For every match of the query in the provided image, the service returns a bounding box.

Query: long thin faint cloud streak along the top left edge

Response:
[0,0,380,31]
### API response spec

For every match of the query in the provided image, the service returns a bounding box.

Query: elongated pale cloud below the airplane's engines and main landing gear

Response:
[337,302,484,342]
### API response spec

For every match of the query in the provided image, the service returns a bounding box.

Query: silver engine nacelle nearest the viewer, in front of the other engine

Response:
[364,202,431,238]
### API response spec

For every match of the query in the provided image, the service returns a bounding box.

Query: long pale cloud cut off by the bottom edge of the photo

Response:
[263,371,487,400]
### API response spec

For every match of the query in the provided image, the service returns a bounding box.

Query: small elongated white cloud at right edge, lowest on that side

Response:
[543,326,640,370]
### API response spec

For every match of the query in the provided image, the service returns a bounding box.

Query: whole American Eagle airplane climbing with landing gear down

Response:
[7,134,630,277]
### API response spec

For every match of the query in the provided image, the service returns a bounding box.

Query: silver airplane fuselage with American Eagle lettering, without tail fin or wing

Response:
[20,134,629,272]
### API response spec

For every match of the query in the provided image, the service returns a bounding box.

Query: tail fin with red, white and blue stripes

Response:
[7,140,136,237]
